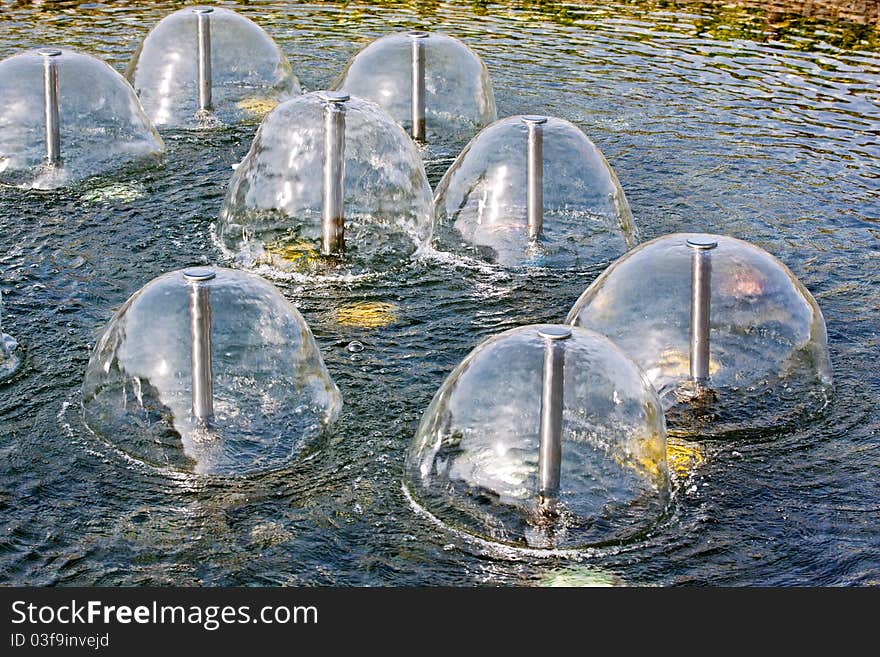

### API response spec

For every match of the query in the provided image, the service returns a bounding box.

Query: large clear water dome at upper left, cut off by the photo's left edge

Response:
[0,48,164,189]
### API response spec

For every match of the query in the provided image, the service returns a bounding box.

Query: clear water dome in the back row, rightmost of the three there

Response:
[335,31,497,142]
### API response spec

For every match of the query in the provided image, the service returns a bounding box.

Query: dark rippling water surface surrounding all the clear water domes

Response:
[0,1,880,585]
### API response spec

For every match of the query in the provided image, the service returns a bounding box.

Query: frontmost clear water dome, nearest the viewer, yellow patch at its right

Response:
[404,325,669,549]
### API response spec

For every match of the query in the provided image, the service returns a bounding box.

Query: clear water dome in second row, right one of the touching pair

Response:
[435,116,637,268]
